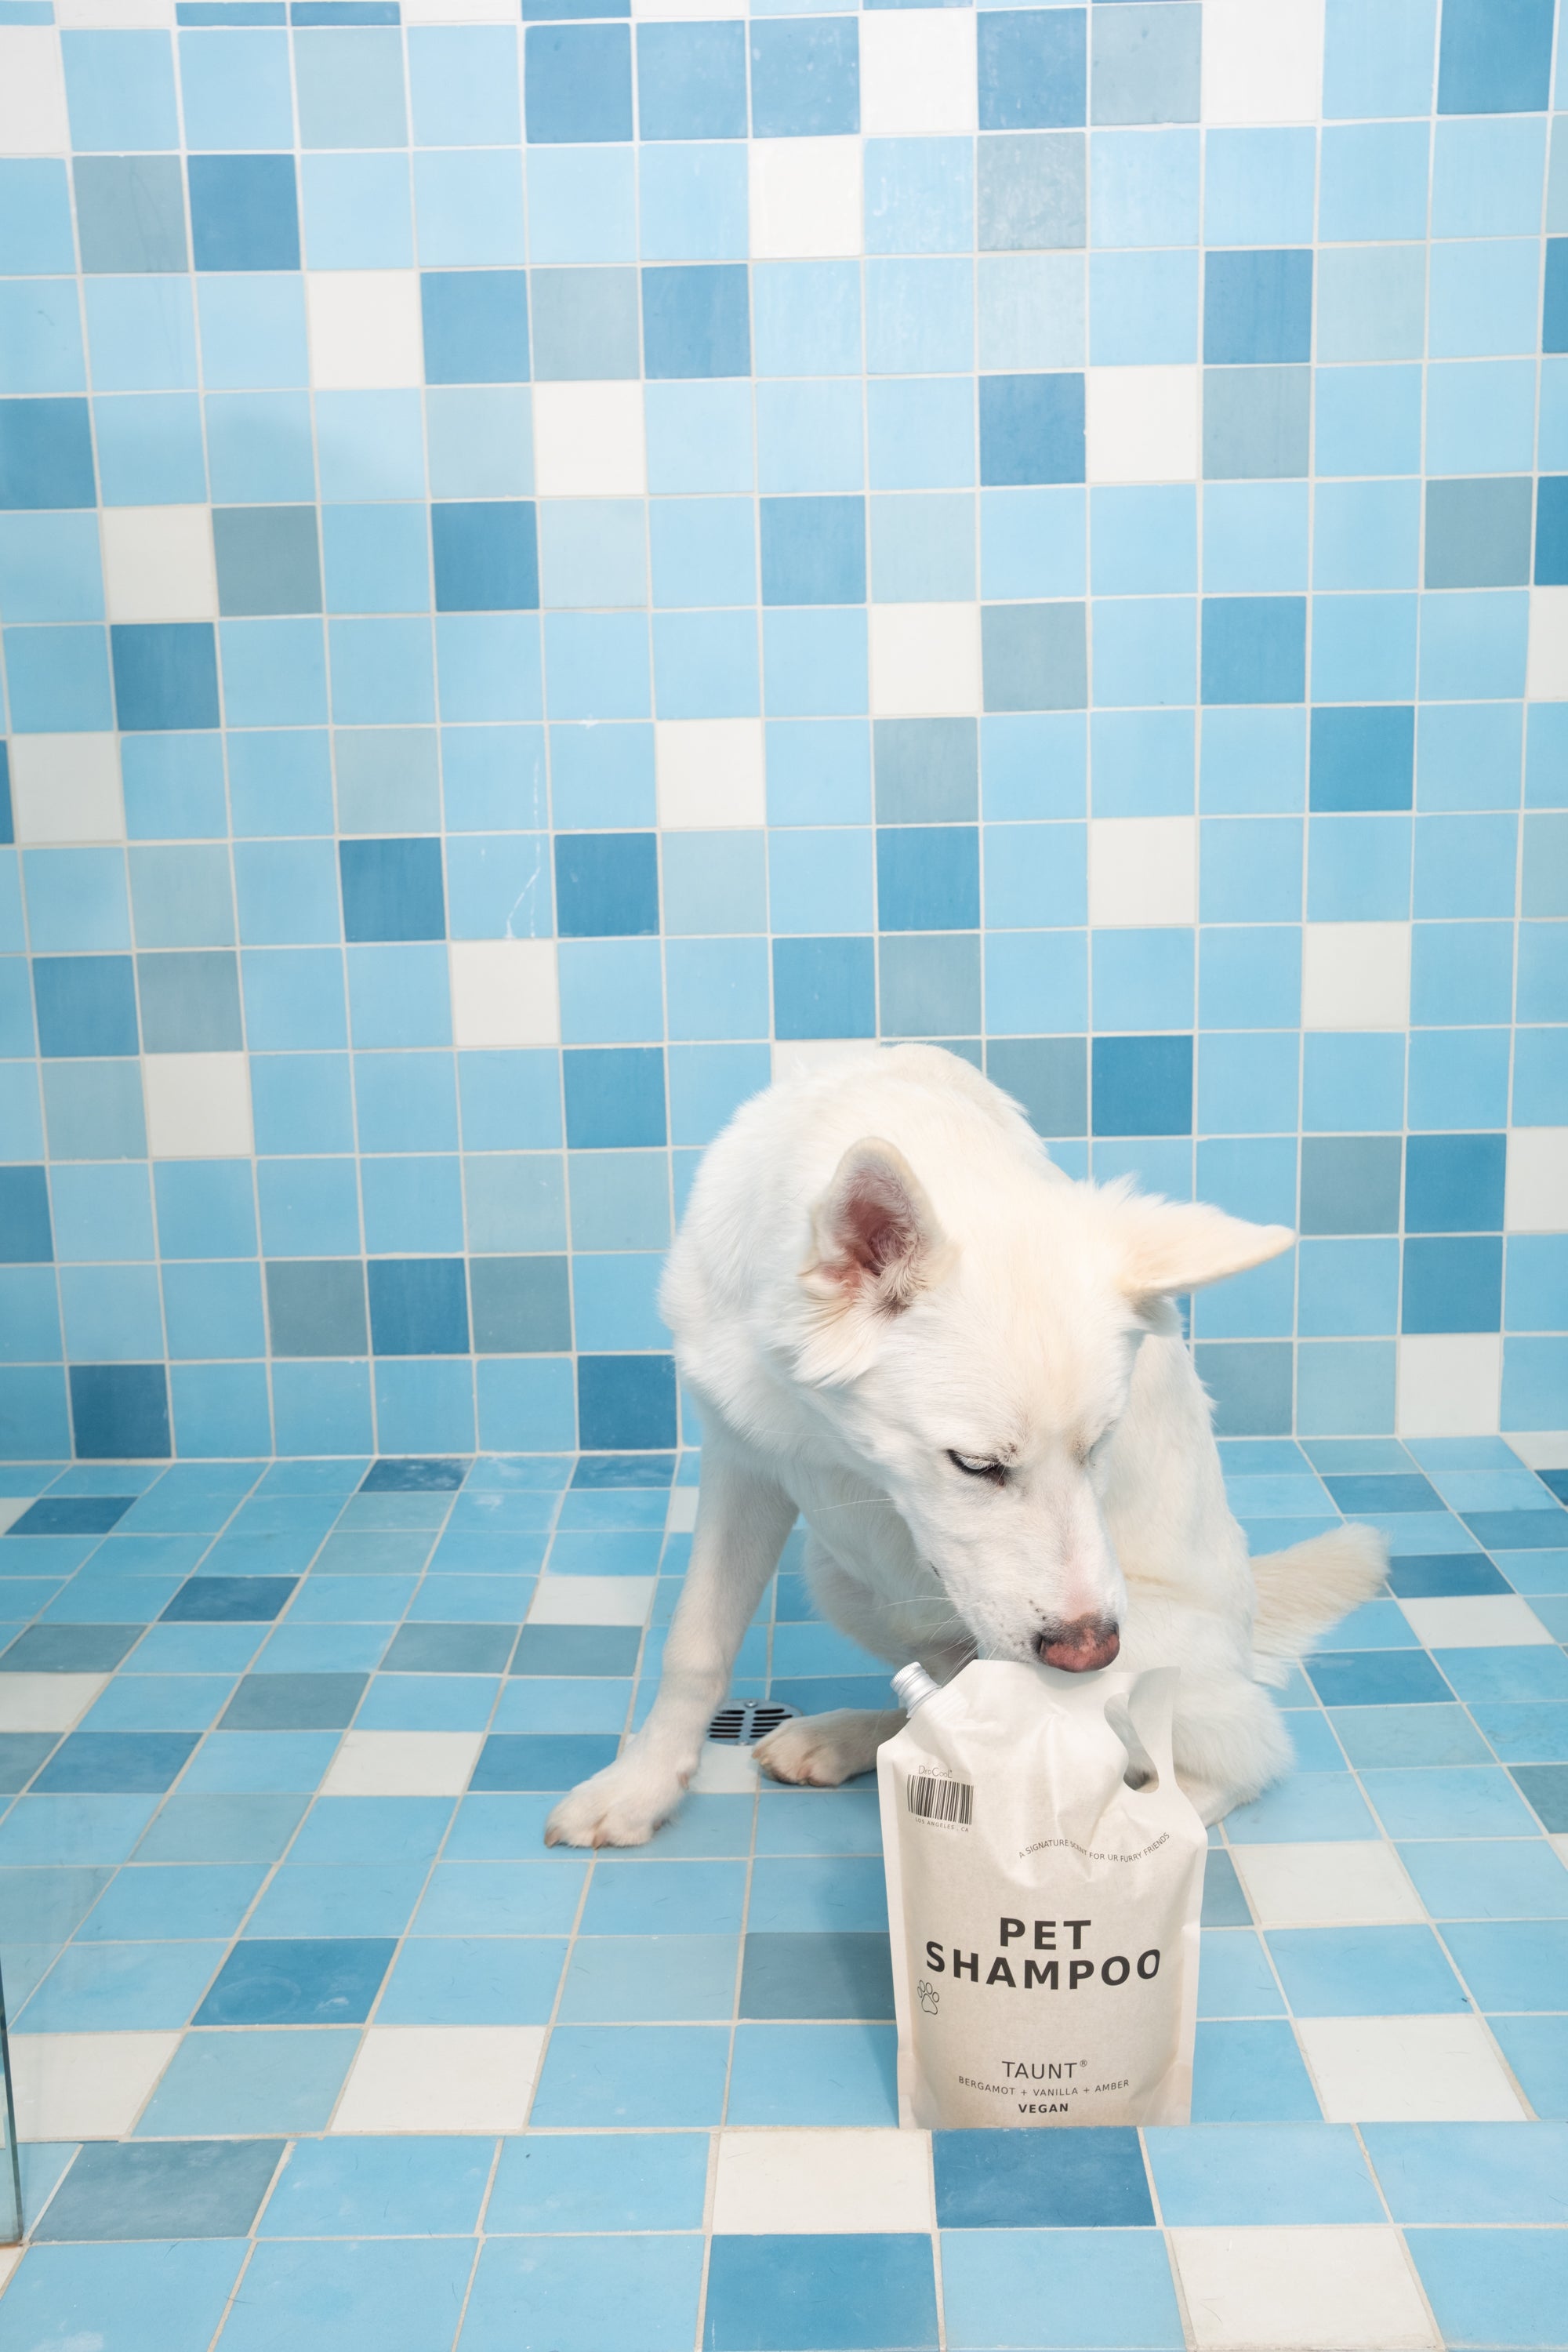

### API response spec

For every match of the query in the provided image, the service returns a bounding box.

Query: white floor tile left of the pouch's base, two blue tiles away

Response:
[329,2025,546,2131]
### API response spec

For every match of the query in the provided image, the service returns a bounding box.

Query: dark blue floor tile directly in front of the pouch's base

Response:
[931,2136,1154,2230]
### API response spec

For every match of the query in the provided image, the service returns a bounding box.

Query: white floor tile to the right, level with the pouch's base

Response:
[1295,2016,1523,2124]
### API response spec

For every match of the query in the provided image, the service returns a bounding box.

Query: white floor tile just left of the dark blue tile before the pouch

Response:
[713,2131,933,2237]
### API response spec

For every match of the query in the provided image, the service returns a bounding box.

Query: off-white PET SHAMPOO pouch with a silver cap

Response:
[877,1661,1208,2129]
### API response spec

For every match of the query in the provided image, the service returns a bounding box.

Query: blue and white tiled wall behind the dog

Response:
[0,0,1568,1458]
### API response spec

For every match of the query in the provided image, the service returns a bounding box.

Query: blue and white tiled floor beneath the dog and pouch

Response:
[0,1437,1568,2352]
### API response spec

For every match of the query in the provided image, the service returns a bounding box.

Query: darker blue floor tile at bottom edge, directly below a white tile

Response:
[703,2230,935,2352]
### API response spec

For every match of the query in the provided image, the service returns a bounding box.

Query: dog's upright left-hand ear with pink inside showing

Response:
[799,1136,952,1381]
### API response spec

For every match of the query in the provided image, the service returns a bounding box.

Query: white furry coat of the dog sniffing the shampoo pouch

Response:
[546,1047,1385,1846]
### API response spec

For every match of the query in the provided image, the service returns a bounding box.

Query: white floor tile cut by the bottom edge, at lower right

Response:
[1171,2227,1439,2352]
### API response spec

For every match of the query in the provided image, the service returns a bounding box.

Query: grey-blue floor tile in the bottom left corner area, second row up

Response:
[33,2140,285,2244]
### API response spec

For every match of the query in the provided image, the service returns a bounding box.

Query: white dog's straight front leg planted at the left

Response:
[546,1432,794,1846]
